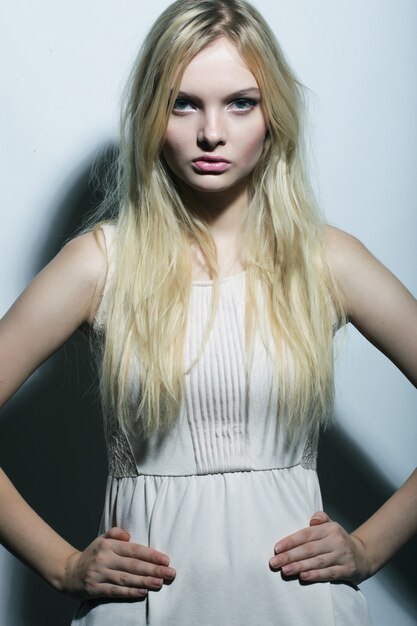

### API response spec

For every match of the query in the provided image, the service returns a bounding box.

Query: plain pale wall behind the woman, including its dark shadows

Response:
[0,0,417,626]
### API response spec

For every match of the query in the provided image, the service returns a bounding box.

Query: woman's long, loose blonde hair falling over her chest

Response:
[96,0,341,436]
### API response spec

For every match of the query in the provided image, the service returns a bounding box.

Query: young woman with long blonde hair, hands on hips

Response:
[0,0,417,626]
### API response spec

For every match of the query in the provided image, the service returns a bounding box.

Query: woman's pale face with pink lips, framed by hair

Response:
[163,38,266,197]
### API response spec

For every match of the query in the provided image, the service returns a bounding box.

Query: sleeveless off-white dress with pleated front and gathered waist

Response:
[72,225,371,626]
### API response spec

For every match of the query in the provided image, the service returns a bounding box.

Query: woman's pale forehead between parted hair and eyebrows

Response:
[180,37,258,91]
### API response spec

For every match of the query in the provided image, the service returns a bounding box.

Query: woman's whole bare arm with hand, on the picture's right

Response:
[270,227,417,583]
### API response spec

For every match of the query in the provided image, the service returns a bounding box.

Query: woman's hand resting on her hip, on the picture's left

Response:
[62,527,175,599]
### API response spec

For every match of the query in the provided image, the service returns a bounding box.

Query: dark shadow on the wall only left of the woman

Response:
[0,144,117,626]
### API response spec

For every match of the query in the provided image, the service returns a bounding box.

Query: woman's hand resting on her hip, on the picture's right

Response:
[269,511,369,584]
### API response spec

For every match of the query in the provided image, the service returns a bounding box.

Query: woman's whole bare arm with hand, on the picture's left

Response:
[0,232,175,598]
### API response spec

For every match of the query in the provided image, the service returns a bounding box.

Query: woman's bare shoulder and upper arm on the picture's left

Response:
[0,227,107,405]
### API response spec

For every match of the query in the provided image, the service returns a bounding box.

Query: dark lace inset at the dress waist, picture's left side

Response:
[105,418,139,478]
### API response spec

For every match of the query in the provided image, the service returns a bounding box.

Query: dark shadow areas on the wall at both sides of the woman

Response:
[0,146,417,626]
